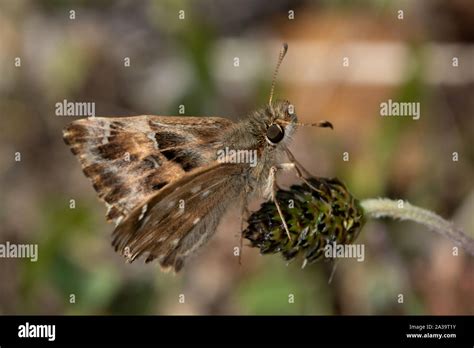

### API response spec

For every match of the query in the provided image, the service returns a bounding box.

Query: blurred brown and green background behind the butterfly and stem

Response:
[0,0,474,315]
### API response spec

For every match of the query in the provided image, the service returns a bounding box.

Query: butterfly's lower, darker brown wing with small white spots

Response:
[113,163,244,272]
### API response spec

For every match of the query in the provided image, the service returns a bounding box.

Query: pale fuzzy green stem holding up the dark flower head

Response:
[360,198,474,255]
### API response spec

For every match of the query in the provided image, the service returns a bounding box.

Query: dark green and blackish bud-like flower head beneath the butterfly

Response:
[243,178,364,263]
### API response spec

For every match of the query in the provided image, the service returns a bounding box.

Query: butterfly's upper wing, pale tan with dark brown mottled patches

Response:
[63,116,233,224]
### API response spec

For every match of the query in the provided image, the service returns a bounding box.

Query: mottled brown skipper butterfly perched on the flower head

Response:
[63,44,332,272]
